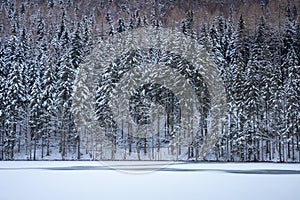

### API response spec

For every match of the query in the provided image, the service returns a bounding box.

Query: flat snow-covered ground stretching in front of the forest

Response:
[0,161,300,200]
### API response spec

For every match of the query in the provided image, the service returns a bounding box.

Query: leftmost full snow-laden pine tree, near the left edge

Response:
[4,32,25,159]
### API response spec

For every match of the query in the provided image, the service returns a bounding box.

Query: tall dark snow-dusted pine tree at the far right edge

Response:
[281,7,300,160]
